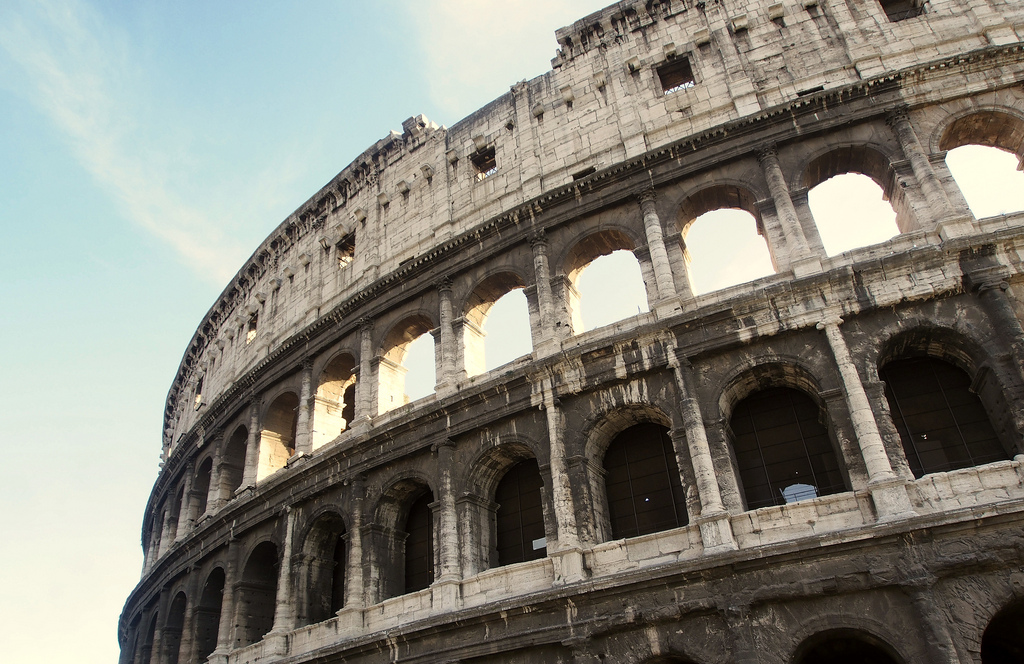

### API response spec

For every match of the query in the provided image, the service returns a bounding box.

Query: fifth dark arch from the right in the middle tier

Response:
[371,472,438,601]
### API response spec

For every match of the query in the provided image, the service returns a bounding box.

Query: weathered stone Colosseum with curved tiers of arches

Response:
[119,0,1024,664]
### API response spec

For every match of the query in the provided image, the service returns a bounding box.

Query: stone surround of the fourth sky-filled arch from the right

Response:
[555,224,657,334]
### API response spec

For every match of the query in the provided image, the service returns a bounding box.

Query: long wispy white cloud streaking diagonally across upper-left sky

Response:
[0,0,245,283]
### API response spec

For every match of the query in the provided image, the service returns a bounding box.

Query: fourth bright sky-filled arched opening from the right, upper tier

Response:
[564,231,649,334]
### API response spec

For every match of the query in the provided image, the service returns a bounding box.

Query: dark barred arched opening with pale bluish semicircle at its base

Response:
[729,387,846,509]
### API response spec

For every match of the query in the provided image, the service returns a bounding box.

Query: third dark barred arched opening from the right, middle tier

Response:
[603,422,689,539]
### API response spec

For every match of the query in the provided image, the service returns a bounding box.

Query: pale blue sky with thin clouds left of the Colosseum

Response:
[0,0,1024,664]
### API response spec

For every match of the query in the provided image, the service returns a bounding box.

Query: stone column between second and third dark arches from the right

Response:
[669,350,736,553]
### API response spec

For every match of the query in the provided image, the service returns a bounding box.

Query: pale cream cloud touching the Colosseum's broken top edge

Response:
[407,0,609,117]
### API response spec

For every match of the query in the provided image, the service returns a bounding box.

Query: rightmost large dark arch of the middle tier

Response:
[871,325,1020,478]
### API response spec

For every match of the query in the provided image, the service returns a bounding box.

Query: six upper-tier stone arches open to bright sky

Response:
[186,105,1024,422]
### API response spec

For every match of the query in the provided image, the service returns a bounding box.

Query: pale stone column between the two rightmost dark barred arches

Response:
[817,316,914,521]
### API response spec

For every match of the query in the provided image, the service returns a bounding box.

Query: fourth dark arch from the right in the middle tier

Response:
[458,437,555,576]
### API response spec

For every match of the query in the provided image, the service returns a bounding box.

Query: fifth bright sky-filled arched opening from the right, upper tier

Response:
[462,273,534,376]
